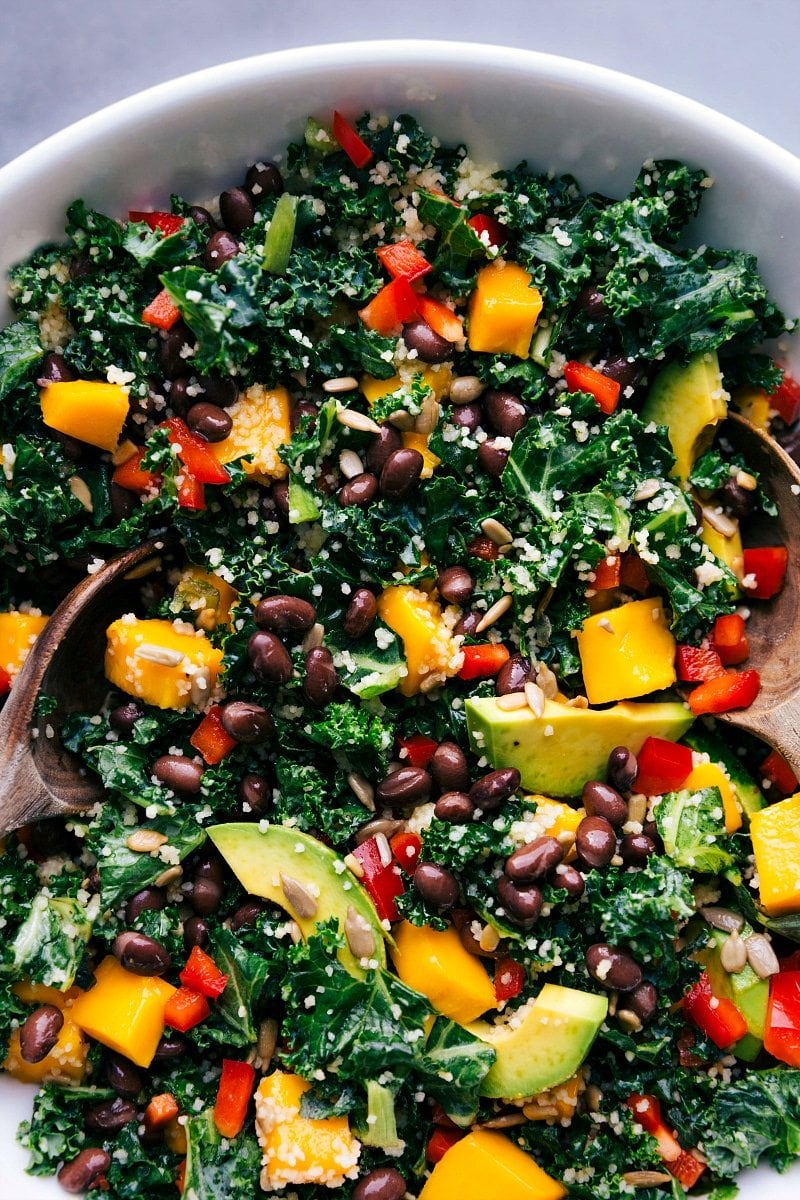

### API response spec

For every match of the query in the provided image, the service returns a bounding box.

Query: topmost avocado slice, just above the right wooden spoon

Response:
[642,350,728,482]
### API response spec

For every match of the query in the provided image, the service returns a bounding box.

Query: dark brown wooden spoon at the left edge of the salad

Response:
[0,540,164,833]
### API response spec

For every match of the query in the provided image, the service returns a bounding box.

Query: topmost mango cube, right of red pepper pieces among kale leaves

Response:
[468,259,542,359]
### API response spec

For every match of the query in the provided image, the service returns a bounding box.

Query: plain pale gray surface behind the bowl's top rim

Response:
[0,0,800,163]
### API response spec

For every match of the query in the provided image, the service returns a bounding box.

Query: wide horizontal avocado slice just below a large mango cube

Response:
[465,696,693,796]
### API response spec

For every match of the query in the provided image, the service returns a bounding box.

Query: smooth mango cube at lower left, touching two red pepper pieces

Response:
[70,954,176,1067]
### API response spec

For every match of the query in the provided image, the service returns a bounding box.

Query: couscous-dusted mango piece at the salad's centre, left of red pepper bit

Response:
[378,583,464,696]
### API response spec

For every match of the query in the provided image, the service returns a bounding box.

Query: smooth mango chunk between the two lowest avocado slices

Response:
[391,920,498,1025]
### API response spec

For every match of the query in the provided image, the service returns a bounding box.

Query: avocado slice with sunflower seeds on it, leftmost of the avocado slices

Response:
[209,822,386,978]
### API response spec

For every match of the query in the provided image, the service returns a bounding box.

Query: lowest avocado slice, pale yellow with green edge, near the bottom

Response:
[467,983,608,1100]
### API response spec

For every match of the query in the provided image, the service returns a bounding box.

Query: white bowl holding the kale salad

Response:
[0,41,800,1200]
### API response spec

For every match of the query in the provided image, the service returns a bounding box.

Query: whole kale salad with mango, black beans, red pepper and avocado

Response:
[0,113,800,1200]
